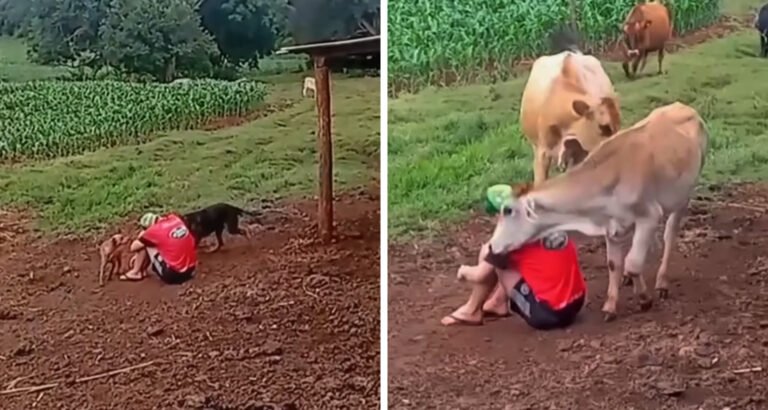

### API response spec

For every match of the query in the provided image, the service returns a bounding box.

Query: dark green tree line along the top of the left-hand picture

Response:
[0,0,380,81]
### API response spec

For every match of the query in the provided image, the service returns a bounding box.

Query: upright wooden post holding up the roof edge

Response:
[315,57,333,243]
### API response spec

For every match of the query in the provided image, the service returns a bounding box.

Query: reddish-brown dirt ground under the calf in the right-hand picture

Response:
[389,185,768,410]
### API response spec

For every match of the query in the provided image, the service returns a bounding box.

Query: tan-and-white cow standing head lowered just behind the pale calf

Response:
[520,46,621,185]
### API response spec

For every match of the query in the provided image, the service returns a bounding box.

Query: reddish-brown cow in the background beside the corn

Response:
[622,1,672,78]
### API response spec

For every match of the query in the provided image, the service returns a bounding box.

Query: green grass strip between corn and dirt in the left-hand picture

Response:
[0,75,380,233]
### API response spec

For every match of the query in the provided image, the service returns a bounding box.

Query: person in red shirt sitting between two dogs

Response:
[120,213,197,284]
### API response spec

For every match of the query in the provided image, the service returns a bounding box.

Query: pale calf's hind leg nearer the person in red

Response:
[624,217,659,311]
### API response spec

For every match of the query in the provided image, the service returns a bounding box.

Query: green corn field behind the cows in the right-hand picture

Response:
[387,0,720,89]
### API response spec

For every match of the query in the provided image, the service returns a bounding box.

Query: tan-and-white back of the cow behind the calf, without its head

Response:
[520,51,613,144]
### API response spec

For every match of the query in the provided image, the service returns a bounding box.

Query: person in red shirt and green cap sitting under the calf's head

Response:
[441,185,586,330]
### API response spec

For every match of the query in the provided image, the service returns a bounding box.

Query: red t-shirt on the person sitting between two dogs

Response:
[139,214,197,272]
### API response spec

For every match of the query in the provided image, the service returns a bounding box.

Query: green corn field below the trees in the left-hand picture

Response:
[0,80,266,159]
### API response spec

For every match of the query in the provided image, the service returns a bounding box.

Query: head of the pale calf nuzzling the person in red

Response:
[490,196,543,255]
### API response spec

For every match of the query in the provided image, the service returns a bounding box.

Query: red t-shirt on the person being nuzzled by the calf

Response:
[509,233,587,310]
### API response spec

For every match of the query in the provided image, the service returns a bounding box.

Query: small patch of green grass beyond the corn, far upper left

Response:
[0,37,67,82]
